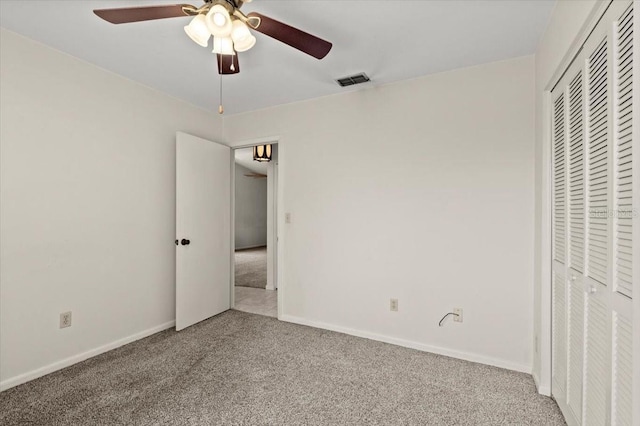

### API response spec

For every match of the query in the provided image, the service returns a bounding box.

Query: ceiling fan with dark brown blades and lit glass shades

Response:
[93,0,332,74]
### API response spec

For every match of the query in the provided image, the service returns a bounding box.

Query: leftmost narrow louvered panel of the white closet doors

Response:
[551,85,568,401]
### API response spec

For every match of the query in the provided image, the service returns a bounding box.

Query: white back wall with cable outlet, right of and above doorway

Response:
[224,56,535,371]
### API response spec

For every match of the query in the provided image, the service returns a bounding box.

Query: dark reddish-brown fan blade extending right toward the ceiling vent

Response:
[247,12,333,59]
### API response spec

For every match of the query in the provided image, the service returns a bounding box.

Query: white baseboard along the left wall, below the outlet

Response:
[0,321,176,392]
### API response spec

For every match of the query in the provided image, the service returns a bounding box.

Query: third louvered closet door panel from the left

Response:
[583,15,612,426]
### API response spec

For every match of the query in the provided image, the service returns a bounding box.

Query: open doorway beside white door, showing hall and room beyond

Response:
[232,144,278,317]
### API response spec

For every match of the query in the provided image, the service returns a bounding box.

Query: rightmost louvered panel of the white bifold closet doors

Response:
[611,4,640,426]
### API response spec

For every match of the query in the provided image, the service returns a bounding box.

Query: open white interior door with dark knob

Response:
[176,132,231,330]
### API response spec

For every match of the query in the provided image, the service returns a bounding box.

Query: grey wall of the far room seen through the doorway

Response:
[235,163,267,250]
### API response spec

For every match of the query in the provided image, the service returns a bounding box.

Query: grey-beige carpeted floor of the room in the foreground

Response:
[0,311,564,425]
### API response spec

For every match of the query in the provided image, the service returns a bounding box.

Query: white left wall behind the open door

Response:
[0,29,221,388]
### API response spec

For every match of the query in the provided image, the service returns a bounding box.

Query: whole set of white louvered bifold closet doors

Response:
[551,0,640,426]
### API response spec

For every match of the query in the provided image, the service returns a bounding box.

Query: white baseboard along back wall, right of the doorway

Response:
[278,315,531,374]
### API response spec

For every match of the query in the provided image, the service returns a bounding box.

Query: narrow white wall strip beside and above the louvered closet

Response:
[533,0,599,394]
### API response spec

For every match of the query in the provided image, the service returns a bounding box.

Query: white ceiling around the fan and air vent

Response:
[0,0,555,114]
